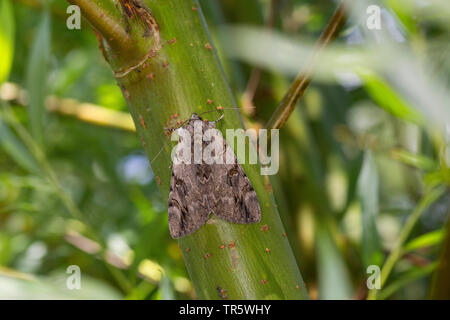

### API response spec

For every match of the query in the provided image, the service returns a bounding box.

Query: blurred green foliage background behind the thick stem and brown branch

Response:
[0,0,450,299]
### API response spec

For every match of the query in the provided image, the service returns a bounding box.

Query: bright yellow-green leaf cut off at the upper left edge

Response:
[0,0,15,84]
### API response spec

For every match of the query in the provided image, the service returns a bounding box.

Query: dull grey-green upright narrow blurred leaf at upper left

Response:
[27,9,51,143]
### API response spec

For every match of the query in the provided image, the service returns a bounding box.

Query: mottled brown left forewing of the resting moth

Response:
[168,164,212,239]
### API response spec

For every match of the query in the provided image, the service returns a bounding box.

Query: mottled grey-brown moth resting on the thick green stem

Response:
[168,113,261,239]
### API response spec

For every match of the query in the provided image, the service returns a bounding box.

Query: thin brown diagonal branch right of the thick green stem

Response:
[266,1,346,129]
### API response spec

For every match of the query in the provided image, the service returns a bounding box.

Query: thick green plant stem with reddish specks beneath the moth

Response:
[71,0,307,299]
